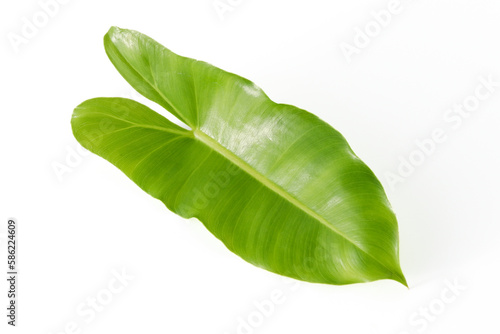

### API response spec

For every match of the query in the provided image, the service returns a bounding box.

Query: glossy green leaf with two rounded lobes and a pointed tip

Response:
[72,28,406,285]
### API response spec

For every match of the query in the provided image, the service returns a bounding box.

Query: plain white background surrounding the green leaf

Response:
[0,0,500,334]
